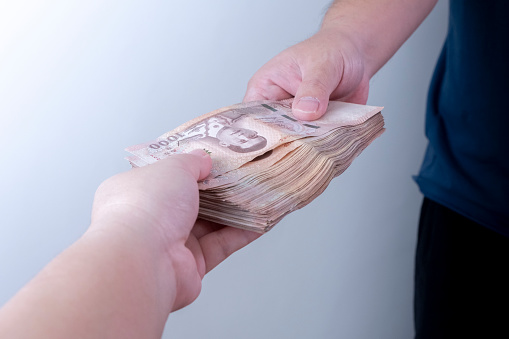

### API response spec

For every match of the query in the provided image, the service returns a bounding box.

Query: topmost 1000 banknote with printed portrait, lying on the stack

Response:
[126,99,381,178]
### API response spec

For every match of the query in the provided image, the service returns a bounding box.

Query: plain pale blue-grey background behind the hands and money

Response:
[0,0,447,339]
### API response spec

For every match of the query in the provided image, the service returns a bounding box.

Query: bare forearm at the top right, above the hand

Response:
[321,0,438,78]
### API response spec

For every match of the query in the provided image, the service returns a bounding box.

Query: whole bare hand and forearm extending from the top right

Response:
[244,0,437,121]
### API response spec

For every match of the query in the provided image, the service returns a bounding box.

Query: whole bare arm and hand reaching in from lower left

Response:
[0,151,260,339]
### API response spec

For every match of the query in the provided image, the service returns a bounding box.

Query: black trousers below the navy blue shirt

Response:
[414,198,509,339]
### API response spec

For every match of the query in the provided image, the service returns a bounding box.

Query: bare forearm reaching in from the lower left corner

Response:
[0,222,175,338]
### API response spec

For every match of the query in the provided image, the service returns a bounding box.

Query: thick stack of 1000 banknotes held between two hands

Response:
[126,99,384,233]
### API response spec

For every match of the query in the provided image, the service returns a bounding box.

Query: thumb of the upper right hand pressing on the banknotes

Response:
[292,65,339,121]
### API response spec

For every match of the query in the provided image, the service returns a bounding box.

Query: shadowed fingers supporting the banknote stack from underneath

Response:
[199,227,261,273]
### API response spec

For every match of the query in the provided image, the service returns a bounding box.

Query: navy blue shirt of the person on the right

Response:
[415,0,509,236]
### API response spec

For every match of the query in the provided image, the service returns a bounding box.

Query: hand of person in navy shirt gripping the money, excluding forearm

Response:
[244,30,369,120]
